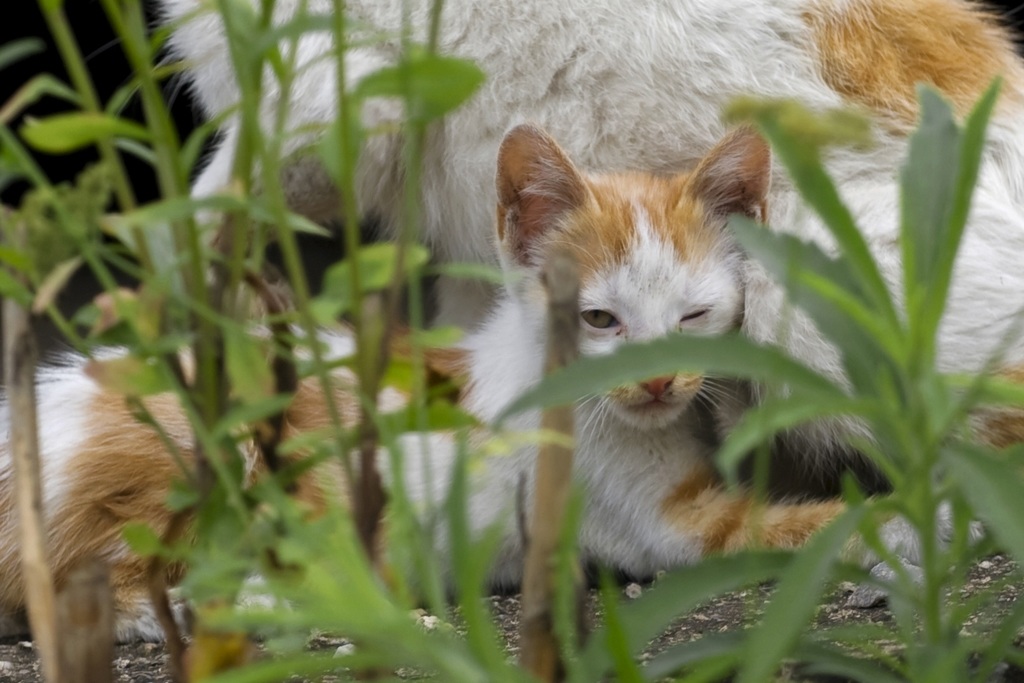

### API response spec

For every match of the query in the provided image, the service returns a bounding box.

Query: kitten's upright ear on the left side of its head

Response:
[497,124,589,266]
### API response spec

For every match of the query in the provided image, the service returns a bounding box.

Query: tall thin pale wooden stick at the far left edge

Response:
[3,228,65,683]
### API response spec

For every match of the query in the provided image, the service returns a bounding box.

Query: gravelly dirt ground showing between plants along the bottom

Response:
[0,555,1024,683]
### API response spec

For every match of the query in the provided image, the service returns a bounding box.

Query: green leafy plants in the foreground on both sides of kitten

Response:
[0,0,1024,681]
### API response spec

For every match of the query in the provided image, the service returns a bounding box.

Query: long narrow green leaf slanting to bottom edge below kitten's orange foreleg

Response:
[737,507,865,683]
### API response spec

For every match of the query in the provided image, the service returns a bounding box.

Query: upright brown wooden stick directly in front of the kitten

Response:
[519,252,580,682]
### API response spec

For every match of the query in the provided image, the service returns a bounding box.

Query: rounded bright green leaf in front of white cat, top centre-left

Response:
[353,51,484,121]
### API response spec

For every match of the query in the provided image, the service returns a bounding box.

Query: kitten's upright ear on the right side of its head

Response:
[691,126,771,222]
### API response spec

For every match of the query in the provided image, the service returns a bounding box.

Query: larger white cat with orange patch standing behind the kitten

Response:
[162,0,1024,464]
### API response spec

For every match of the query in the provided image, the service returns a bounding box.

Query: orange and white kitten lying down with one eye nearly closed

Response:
[0,126,929,640]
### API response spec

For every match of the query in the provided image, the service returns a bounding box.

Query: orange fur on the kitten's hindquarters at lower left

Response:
[0,368,370,615]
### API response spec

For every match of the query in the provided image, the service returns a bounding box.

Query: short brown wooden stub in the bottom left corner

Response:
[57,560,114,683]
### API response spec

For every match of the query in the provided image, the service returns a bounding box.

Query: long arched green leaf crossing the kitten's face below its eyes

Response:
[498,335,845,421]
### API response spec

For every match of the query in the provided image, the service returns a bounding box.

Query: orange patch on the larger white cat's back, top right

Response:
[804,0,1022,127]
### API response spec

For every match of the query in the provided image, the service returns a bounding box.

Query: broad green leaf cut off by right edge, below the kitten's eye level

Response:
[943,443,1024,562]
